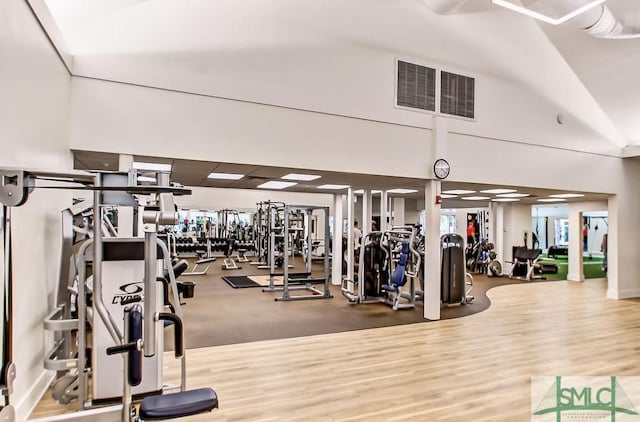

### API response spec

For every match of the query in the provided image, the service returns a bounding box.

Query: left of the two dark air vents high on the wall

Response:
[396,60,436,111]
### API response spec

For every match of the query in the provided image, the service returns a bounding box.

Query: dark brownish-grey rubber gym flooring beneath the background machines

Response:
[172,259,556,348]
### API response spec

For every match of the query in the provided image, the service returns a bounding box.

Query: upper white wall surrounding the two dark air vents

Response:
[58,0,615,155]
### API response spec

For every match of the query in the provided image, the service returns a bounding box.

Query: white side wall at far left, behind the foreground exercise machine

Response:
[0,0,73,420]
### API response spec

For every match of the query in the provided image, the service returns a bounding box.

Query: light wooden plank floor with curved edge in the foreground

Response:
[32,280,640,422]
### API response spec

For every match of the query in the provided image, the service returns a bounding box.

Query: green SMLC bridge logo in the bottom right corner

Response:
[533,377,638,422]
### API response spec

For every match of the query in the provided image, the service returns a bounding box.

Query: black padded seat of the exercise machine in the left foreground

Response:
[140,388,218,421]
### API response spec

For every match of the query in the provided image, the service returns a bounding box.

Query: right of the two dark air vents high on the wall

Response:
[440,71,476,119]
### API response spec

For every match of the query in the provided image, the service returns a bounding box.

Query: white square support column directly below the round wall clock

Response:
[424,180,441,320]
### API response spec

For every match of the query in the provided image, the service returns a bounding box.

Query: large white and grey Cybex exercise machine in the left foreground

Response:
[0,169,218,422]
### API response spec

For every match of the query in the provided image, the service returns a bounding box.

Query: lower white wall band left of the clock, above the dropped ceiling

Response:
[71,77,431,177]
